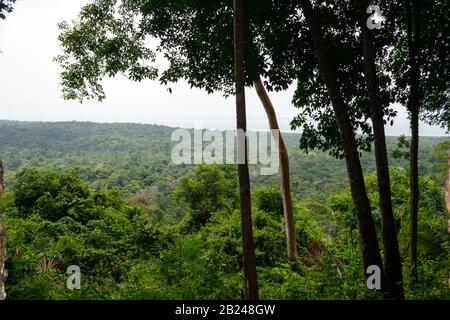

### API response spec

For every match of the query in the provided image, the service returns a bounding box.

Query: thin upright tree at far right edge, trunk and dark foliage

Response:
[405,0,450,282]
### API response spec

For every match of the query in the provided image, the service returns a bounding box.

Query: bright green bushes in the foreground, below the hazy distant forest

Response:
[0,159,450,299]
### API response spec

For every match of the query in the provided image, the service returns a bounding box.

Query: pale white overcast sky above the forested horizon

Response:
[0,0,445,136]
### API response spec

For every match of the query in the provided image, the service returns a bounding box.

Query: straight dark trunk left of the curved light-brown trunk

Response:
[234,0,258,300]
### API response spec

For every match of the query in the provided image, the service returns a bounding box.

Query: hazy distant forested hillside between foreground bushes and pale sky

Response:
[0,121,449,199]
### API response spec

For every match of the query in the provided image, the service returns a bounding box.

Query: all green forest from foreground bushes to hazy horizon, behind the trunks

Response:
[0,121,450,299]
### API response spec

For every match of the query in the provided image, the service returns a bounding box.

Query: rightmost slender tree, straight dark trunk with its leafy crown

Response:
[384,0,450,282]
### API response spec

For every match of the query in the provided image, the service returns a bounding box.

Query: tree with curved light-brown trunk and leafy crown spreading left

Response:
[53,0,297,258]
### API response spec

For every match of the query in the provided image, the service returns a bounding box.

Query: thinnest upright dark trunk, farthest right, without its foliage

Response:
[406,0,420,282]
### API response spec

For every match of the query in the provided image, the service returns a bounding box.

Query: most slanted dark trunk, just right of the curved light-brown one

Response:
[301,0,385,289]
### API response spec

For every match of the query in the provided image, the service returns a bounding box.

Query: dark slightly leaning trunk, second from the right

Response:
[358,1,405,300]
